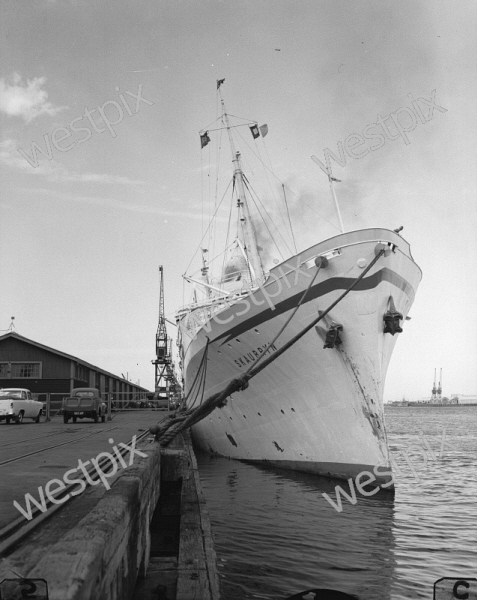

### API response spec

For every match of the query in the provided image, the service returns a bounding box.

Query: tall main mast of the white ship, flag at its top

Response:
[217,81,263,283]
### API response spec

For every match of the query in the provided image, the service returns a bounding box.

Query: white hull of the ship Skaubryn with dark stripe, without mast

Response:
[178,229,421,484]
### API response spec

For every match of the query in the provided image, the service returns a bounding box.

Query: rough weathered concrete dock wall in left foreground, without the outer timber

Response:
[0,436,161,600]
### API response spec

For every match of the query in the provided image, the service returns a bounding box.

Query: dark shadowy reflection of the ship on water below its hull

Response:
[198,454,395,600]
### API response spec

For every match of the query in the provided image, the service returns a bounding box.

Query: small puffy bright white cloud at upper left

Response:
[0,73,67,123]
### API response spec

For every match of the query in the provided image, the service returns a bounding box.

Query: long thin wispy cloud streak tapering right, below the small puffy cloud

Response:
[0,139,145,185]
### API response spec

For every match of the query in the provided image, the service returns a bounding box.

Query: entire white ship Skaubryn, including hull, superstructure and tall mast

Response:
[176,80,421,489]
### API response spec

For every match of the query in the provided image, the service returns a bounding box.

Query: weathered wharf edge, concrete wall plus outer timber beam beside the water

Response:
[0,432,220,600]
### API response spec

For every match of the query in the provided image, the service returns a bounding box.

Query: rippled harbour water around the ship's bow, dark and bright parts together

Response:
[194,406,477,600]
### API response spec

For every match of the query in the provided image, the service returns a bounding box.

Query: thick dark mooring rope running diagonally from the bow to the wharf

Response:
[150,244,386,446]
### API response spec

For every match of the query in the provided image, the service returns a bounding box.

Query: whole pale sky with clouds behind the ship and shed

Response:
[0,0,477,401]
